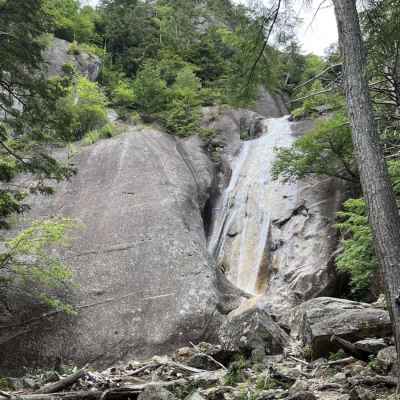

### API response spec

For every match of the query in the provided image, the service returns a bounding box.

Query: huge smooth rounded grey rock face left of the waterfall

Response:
[0,126,230,372]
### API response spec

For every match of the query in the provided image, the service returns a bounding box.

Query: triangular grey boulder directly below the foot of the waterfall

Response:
[218,299,290,356]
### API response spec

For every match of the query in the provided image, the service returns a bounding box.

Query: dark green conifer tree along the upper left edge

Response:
[0,0,73,227]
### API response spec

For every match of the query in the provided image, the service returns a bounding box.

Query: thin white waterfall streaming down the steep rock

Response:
[208,116,294,295]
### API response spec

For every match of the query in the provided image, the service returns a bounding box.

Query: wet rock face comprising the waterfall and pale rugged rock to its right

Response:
[208,113,343,314]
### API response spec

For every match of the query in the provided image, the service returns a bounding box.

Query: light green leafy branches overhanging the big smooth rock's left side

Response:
[0,218,77,313]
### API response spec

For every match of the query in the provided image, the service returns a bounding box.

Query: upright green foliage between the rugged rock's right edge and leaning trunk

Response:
[336,199,378,297]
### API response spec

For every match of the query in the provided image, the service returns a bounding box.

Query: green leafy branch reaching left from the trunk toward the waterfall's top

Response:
[272,113,358,182]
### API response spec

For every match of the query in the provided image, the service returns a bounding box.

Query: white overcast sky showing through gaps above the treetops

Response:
[82,0,337,55]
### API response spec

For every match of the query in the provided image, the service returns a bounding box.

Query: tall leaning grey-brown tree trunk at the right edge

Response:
[333,0,400,378]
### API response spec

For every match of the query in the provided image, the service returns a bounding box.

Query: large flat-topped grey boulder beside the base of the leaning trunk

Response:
[287,297,392,358]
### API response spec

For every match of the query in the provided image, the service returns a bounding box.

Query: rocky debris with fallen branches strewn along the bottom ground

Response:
[0,343,397,400]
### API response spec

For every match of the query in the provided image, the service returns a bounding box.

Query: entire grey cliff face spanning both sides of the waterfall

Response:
[0,89,346,371]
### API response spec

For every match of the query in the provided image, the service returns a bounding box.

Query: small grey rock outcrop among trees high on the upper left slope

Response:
[44,38,101,81]
